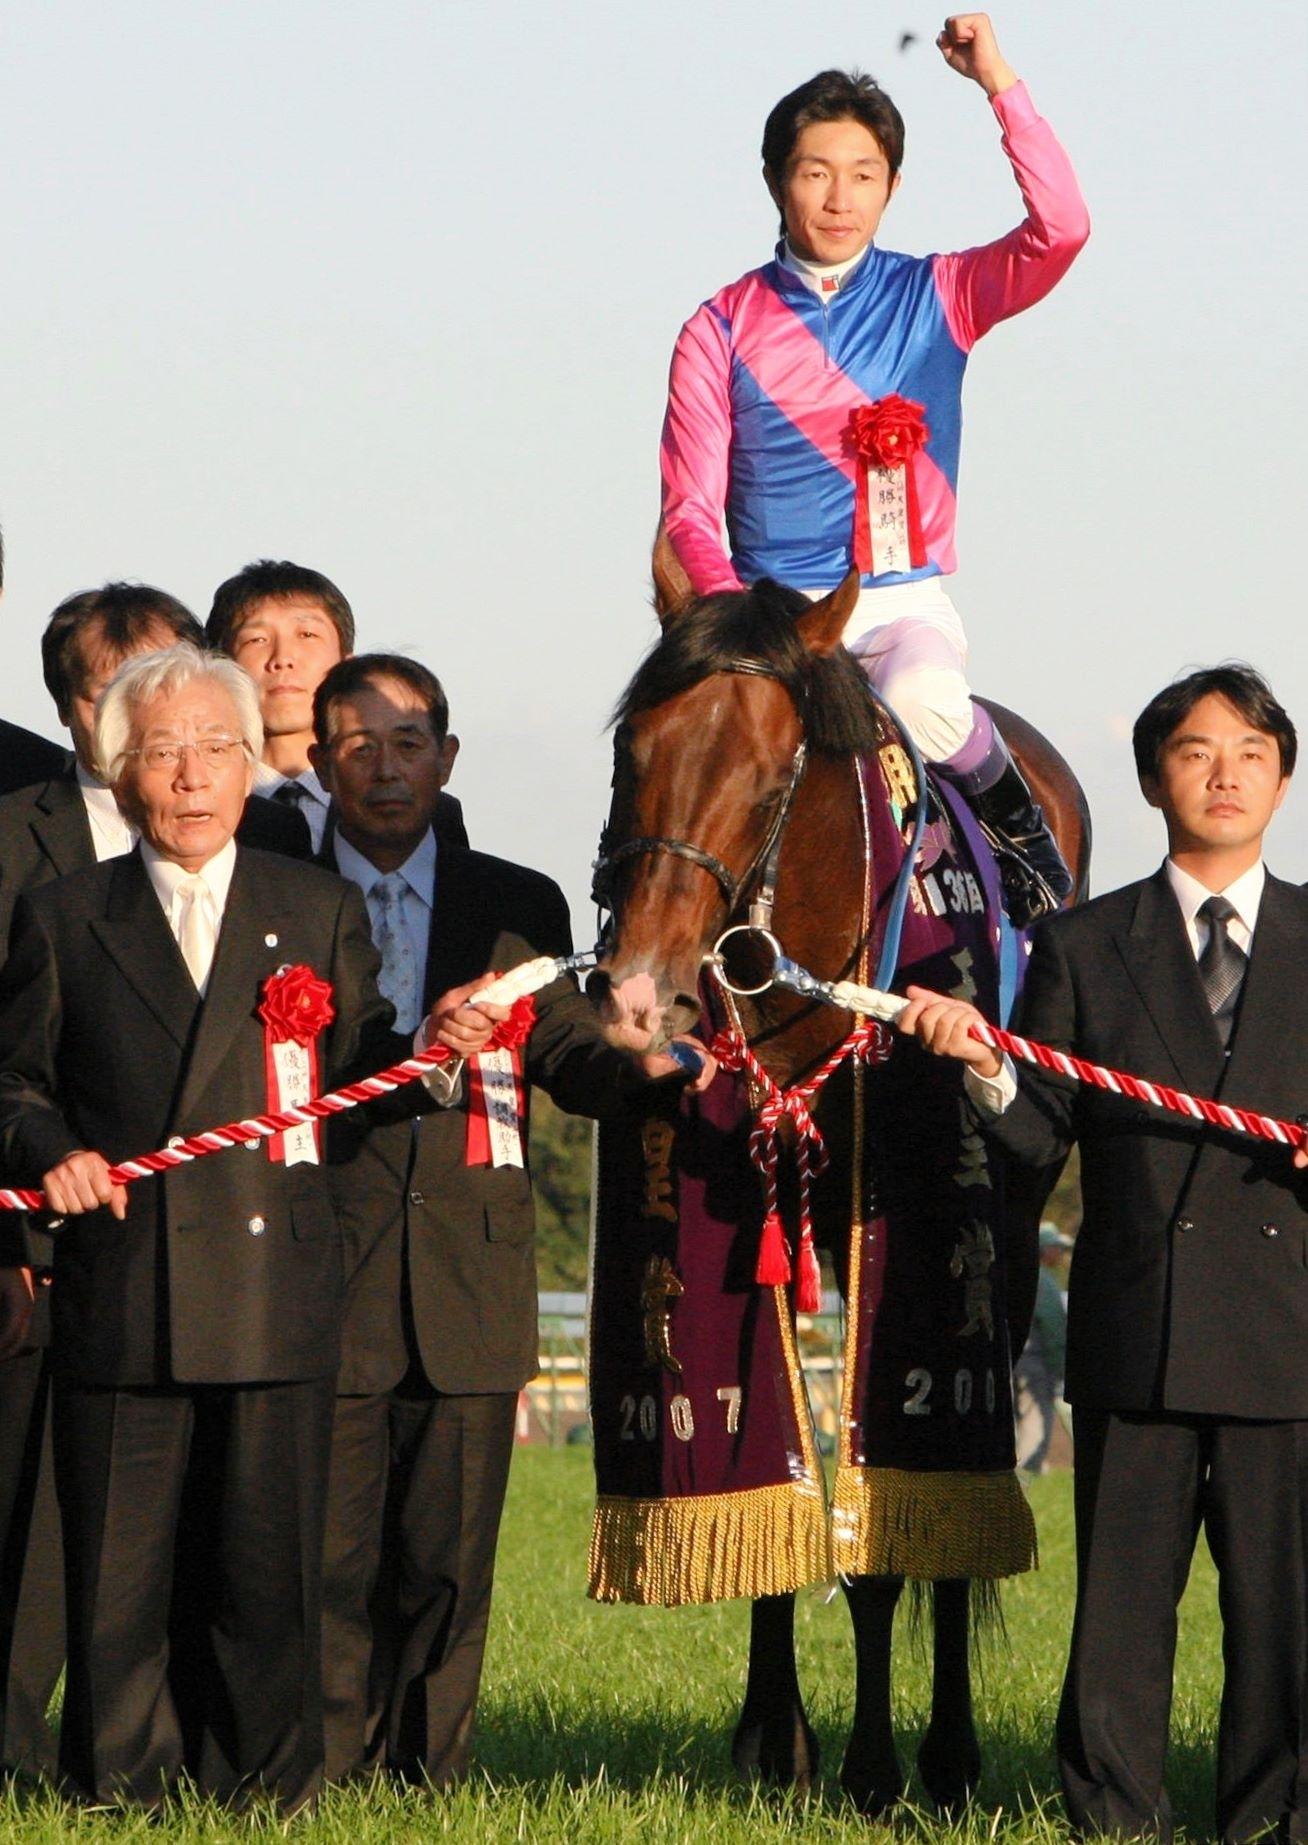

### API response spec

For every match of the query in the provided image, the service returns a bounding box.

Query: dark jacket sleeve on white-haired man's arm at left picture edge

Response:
[0,897,81,1186]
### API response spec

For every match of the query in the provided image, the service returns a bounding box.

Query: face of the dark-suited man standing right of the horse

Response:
[1142,692,1290,870]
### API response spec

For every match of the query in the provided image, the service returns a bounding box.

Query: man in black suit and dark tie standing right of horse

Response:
[902,666,1308,1841]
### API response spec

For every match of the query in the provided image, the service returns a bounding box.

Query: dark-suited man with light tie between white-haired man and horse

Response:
[314,655,710,1786]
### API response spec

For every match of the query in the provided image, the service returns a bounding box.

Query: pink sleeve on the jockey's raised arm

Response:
[932,83,1090,352]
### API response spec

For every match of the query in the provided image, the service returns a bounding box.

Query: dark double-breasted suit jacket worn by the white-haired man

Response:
[0,849,393,1386]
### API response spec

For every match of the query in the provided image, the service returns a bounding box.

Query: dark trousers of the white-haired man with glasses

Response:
[55,1378,332,1810]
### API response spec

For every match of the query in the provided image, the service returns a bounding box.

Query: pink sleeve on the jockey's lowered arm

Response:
[659,306,743,596]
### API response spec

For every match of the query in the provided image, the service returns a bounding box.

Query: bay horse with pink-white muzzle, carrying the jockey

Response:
[589,560,1090,1815]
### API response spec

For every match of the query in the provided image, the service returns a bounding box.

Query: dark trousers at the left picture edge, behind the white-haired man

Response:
[0,1351,63,1775]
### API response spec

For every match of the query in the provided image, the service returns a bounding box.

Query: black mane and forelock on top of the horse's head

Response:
[614,577,889,755]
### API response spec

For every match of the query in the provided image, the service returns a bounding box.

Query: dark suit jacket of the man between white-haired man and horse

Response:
[332,843,644,1397]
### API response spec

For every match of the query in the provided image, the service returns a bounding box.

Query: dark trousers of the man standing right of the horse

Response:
[1057,1410,1308,1841]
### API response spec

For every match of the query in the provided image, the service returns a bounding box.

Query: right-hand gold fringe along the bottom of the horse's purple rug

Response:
[832,1467,1039,1581]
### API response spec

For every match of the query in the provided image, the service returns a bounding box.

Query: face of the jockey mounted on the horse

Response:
[764,120,898,262]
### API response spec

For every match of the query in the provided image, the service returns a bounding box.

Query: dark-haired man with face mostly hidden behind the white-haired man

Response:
[0,583,310,1773]
